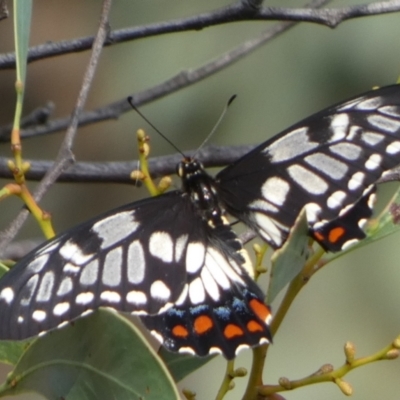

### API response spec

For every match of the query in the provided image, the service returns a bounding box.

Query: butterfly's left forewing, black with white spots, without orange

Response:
[0,192,204,339]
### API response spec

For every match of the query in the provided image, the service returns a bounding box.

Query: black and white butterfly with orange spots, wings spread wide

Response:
[0,85,400,359]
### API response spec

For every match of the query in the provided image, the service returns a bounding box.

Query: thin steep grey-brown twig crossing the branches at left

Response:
[0,0,112,254]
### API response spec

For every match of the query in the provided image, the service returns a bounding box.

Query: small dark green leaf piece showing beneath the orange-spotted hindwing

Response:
[159,347,215,382]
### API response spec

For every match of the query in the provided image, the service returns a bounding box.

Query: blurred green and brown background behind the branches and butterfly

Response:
[0,0,400,400]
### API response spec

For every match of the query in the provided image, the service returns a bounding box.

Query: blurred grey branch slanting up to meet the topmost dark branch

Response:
[0,0,330,142]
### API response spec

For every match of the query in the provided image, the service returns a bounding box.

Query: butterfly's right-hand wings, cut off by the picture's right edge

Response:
[217,85,400,251]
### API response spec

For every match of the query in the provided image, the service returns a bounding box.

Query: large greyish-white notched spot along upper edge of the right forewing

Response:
[264,127,319,163]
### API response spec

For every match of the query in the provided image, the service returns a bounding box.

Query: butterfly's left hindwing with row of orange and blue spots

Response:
[141,225,271,359]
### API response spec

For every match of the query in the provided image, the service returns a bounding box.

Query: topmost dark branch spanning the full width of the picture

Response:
[0,0,400,69]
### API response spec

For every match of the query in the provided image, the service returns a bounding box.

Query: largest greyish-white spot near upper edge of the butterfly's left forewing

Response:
[91,211,140,249]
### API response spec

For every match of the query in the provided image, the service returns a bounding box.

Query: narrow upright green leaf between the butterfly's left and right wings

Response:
[267,209,310,304]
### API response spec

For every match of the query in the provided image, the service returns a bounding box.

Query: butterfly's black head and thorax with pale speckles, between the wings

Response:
[177,158,225,227]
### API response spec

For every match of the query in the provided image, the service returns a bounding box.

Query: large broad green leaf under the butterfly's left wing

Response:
[0,309,179,400]
